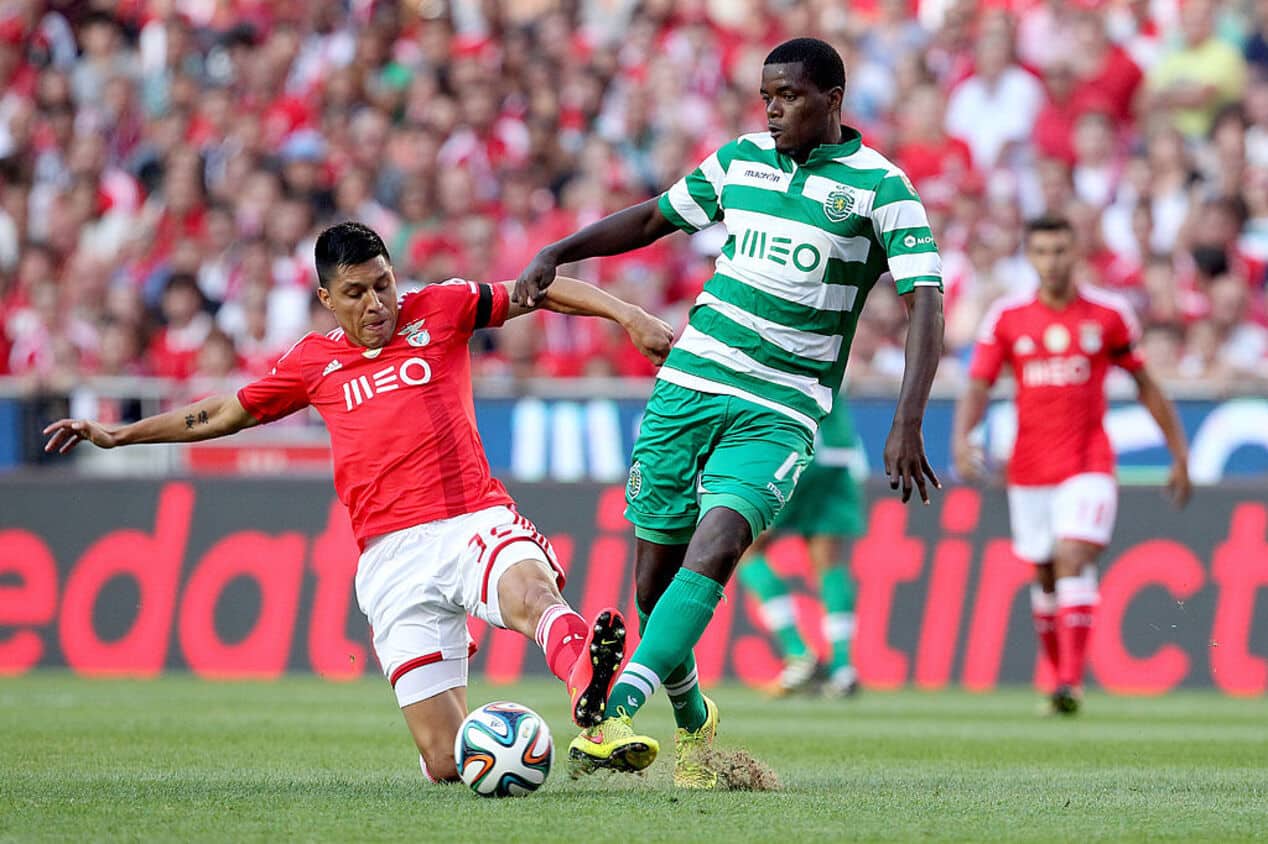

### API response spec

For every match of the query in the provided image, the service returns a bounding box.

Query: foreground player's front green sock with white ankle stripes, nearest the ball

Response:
[609,569,723,722]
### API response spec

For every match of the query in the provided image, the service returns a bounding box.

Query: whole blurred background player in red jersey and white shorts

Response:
[952,217,1189,713]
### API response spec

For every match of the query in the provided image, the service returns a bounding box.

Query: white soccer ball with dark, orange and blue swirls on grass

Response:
[454,701,554,797]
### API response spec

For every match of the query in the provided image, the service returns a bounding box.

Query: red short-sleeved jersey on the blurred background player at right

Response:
[969,288,1145,487]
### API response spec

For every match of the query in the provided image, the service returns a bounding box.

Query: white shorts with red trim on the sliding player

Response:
[356,506,564,706]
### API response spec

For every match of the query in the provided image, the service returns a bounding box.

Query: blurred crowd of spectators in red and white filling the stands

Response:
[0,0,1268,393]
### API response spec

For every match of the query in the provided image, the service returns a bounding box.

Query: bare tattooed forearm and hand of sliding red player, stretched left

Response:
[44,395,257,454]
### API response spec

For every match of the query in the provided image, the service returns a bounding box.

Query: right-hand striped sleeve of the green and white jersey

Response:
[871,170,942,294]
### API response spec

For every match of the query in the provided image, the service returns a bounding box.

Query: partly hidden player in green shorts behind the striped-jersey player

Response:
[738,395,866,697]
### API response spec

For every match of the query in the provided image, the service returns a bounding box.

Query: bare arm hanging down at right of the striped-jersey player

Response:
[884,286,942,504]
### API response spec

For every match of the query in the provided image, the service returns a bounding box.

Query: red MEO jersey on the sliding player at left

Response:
[238,280,514,547]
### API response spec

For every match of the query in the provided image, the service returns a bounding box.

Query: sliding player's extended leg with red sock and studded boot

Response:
[497,559,625,727]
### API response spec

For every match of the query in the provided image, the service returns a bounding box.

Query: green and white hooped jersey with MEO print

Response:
[659,127,942,431]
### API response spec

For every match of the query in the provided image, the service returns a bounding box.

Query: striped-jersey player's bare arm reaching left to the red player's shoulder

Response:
[511,198,677,308]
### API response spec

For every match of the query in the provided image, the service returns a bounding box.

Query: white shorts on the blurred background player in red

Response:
[1008,473,1118,563]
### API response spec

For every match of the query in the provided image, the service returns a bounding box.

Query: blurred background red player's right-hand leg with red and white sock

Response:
[1052,539,1102,715]
